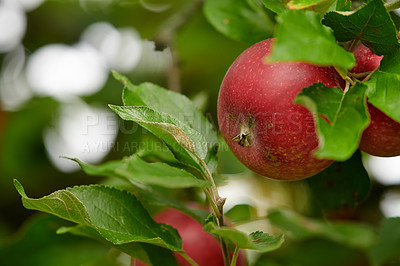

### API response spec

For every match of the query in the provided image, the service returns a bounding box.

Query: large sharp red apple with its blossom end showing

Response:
[217,38,344,180]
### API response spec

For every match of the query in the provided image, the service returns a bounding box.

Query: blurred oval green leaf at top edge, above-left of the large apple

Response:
[203,0,274,43]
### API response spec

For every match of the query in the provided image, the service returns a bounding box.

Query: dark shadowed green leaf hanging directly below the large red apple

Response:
[306,152,371,210]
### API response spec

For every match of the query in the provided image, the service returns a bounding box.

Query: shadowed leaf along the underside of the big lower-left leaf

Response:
[57,225,177,266]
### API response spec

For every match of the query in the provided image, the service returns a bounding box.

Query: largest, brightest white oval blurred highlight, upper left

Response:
[26,44,108,100]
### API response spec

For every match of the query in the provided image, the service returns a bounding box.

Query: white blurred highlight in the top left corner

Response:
[0,0,26,53]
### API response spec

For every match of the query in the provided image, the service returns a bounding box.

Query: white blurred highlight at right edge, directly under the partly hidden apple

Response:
[363,155,400,185]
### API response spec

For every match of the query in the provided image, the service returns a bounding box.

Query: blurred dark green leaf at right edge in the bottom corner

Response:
[369,217,400,265]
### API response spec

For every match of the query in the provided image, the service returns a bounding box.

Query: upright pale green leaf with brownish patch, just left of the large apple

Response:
[110,72,218,172]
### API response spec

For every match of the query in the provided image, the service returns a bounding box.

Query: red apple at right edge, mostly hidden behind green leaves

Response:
[351,44,400,157]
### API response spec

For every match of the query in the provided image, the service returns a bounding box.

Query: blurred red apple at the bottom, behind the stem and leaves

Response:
[134,208,246,266]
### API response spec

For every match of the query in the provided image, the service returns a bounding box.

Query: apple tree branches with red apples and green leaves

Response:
[4,0,400,266]
